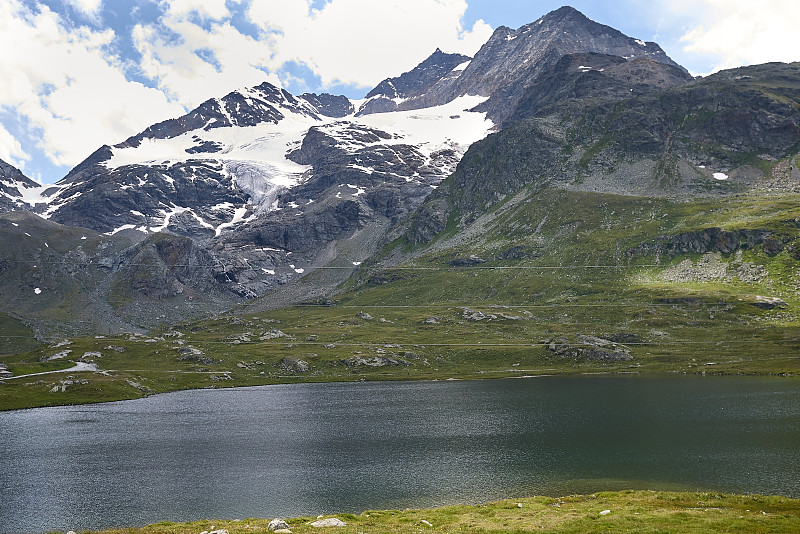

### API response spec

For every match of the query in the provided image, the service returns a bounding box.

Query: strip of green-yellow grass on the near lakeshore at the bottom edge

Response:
[79,491,800,534]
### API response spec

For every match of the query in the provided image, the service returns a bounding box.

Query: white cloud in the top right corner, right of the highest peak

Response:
[669,0,800,71]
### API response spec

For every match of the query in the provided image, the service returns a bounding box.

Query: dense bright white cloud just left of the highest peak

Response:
[248,0,492,87]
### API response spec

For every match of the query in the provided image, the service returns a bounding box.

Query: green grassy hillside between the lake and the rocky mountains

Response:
[0,189,800,409]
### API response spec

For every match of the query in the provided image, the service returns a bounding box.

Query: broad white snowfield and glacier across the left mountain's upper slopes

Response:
[102,93,494,208]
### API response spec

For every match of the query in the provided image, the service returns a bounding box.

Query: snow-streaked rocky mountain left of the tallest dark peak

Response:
[0,54,493,333]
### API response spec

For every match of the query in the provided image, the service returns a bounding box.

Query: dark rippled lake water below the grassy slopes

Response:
[0,376,800,532]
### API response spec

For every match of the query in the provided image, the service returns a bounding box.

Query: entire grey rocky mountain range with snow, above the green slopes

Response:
[0,7,796,348]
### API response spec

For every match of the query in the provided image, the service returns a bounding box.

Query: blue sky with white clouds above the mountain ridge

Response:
[0,0,800,183]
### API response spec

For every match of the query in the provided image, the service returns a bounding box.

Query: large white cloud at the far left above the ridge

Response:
[0,0,184,169]
